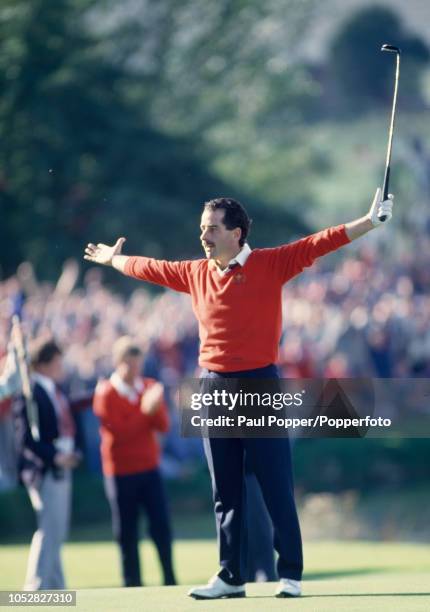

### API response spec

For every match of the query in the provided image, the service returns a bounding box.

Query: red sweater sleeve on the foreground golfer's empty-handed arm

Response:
[124,257,191,293]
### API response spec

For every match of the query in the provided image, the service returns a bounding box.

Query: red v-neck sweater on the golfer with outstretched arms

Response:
[124,225,350,372]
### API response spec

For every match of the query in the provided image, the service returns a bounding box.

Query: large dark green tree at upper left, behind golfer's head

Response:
[0,0,312,276]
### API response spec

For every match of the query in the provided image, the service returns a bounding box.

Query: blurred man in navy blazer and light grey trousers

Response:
[17,339,80,591]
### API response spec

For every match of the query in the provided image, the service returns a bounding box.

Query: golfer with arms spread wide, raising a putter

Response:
[84,189,393,599]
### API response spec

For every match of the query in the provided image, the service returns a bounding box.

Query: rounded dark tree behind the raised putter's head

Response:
[329,6,429,112]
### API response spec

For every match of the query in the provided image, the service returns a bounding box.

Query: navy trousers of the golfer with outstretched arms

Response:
[202,365,303,585]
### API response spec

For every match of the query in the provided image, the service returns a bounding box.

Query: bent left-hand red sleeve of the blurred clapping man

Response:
[93,383,147,440]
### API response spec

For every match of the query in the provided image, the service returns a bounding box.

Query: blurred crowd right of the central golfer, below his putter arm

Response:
[281,234,430,378]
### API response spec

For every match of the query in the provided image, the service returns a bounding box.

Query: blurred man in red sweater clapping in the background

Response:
[94,336,176,586]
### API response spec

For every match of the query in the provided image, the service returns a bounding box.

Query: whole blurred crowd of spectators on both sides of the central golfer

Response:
[0,234,430,395]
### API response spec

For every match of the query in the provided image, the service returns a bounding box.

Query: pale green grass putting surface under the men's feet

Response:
[0,540,430,612]
